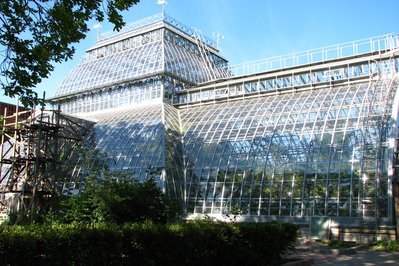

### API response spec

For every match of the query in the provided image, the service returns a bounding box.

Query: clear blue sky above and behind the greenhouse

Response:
[0,0,399,103]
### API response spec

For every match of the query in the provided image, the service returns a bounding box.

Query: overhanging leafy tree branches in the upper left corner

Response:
[0,0,140,106]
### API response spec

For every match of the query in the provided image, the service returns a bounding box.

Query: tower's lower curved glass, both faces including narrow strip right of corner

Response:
[75,103,182,198]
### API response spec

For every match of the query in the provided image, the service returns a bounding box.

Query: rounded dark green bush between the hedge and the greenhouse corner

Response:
[50,175,179,224]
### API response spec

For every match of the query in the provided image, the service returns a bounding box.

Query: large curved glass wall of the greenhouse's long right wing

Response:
[181,79,398,217]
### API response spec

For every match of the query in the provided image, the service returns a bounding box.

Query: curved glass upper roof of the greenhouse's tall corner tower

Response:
[55,14,228,98]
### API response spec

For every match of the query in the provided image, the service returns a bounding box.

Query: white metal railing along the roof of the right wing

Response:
[229,33,399,76]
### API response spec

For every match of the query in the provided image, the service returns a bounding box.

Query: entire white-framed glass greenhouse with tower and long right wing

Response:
[47,13,399,229]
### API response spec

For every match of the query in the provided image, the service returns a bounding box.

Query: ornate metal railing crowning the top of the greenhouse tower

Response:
[97,13,217,50]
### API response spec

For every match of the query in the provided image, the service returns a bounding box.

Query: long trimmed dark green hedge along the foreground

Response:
[0,221,298,265]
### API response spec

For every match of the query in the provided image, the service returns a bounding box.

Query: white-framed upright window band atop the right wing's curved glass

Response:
[177,55,399,106]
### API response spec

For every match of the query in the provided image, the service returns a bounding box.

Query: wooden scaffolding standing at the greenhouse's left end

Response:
[0,104,90,222]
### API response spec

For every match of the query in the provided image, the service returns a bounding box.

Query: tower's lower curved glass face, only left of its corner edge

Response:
[81,104,165,178]
